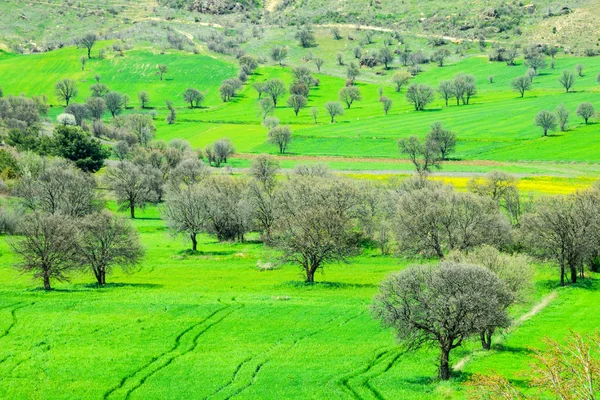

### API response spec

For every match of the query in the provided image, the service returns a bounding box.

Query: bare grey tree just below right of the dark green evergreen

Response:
[104,161,162,218]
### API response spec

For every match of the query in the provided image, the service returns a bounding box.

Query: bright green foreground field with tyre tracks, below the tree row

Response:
[0,208,598,399]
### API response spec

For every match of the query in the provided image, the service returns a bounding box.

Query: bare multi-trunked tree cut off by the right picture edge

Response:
[521,190,600,286]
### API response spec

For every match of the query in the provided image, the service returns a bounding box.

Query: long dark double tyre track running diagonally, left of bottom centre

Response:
[103,304,243,399]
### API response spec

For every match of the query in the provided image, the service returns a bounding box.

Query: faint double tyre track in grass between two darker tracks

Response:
[213,311,365,400]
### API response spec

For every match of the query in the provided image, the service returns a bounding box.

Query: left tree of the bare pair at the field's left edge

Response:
[9,213,79,290]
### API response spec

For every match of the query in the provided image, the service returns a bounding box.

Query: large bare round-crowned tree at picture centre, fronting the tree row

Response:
[272,176,360,283]
